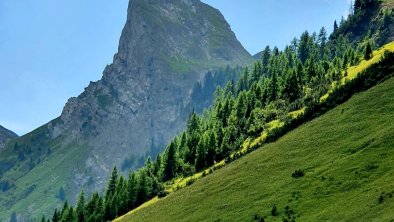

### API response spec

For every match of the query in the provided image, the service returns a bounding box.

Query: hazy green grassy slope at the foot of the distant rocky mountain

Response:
[0,127,88,221]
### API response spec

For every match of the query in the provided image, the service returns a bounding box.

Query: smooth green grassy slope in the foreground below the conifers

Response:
[120,78,394,221]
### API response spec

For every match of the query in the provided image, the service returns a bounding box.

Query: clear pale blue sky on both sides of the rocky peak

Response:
[0,0,349,135]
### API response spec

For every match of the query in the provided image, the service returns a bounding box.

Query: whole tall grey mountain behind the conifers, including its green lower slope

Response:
[0,0,253,220]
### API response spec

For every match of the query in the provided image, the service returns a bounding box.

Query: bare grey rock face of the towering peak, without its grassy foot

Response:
[50,0,251,177]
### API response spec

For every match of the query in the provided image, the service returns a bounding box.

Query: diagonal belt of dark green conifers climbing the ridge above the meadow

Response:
[35,0,394,222]
